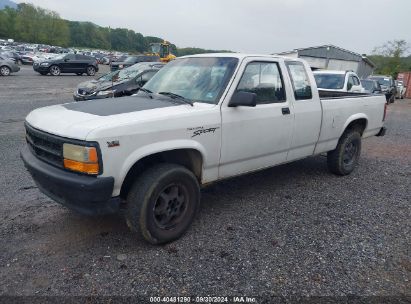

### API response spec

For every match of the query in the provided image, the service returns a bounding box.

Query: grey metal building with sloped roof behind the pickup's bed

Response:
[277,45,375,78]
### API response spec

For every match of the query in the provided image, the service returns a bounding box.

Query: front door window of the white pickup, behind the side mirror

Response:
[236,62,285,104]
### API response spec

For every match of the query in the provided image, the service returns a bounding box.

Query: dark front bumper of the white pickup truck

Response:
[20,146,120,215]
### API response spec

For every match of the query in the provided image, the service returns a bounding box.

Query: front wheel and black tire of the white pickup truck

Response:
[126,163,200,244]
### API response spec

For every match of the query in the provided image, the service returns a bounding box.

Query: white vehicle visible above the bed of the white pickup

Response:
[313,70,364,93]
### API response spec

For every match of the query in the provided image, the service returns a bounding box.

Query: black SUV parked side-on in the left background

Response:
[33,54,98,76]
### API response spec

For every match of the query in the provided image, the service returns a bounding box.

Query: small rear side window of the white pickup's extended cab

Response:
[286,61,313,100]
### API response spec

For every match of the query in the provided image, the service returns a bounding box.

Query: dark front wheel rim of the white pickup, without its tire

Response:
[153,184,189,229]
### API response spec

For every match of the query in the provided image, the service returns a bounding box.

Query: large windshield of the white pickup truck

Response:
[144,57,238,104]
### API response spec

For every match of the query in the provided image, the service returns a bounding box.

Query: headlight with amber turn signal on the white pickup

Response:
[63,144,100,174]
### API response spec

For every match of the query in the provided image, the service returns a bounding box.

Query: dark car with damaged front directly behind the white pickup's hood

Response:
[73,62,164,101]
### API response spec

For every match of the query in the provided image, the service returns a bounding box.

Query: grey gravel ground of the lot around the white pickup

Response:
[0,66,411,302]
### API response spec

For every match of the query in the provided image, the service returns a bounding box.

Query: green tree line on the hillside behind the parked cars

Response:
[0,3,229,56]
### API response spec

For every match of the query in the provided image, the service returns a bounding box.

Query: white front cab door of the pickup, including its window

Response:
[219,57,294,178]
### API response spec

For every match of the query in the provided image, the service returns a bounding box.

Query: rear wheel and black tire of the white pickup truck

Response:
[327,129,361,175]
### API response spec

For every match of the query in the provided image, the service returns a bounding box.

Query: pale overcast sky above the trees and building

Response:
[15,0,411,54]
